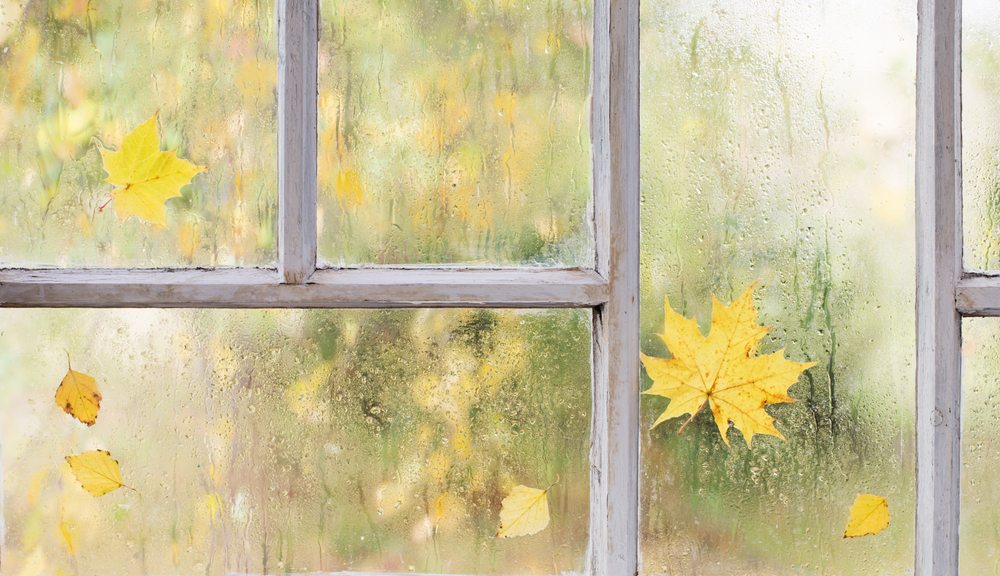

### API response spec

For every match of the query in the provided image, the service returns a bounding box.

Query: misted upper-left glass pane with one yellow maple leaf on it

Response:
[0,0,277,267]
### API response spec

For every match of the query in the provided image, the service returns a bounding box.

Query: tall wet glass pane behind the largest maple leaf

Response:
[640,0,916,576]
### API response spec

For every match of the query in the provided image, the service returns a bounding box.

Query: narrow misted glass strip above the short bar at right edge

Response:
[962,0,1000,270]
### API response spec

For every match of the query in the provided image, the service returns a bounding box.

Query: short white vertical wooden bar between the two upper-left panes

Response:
[276,0,319,284]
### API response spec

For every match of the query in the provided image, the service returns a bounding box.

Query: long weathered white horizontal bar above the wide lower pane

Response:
[0,268,608,308]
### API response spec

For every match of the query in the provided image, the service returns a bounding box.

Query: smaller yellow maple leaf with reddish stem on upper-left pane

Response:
[98,114,207,226]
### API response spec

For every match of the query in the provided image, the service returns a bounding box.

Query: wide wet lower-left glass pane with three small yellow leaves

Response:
[0,310,591,576]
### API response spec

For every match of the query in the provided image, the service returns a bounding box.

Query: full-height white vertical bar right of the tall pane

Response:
[915,0,962,576]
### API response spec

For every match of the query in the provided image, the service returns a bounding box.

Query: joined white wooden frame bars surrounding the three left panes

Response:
[0,0,639,576]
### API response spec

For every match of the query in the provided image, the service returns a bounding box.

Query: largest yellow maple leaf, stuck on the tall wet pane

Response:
[641,284,816,446]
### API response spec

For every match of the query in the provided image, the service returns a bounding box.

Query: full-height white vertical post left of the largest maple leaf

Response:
[589,0,639,576]
